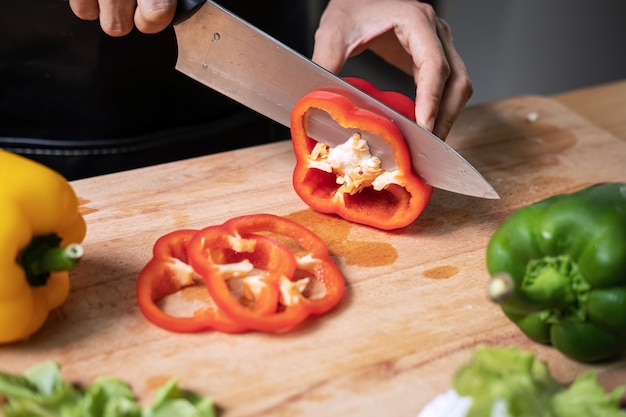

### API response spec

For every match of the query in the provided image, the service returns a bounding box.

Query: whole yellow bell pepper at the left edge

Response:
[0,149,86,343]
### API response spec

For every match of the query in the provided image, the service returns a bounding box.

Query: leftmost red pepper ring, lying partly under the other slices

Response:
[136,230,278,333]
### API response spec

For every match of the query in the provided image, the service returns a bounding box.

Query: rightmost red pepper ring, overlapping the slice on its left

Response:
[188,214,345,332]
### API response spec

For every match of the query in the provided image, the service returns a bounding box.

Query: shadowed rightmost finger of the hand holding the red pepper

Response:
[433,21,474,139]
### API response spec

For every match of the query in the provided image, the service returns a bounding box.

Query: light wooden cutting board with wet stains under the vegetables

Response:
[0,96,626,417]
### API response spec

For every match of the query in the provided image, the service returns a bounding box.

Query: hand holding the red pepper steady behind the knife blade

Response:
[312,0,473,139]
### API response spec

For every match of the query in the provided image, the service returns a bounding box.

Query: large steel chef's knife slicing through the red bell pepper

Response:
[174,0,499,198]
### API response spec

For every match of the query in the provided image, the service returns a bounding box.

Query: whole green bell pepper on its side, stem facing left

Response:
[486,183,626,362]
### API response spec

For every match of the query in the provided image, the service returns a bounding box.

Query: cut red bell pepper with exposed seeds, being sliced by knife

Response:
[291,78,432,230]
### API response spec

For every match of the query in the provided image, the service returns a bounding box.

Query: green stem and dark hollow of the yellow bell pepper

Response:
[18,235,84,287]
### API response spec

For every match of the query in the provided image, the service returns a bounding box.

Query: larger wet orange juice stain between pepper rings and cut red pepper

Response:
[285,209,398,267]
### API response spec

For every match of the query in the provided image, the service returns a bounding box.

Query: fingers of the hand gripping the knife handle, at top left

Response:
[69,0,176,36]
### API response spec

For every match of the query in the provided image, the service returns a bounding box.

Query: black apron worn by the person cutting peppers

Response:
[0,0,317,179]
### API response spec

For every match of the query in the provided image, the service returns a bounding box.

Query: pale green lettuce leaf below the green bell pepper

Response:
[453,345,626,417]
